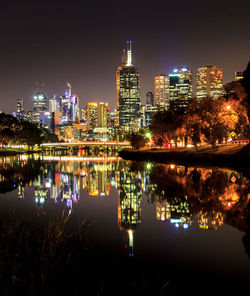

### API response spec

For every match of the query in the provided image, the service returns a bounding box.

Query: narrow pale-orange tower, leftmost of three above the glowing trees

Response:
[155,74,169,110]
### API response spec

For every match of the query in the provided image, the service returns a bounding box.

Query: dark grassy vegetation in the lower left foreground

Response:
[0,213,176,295]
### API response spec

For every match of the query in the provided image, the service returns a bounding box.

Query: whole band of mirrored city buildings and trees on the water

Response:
[0,156,248,243]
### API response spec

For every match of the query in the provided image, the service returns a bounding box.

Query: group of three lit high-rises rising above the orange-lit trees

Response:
[151,66,224,111]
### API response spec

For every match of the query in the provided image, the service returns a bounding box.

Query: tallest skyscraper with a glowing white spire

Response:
[116,41,141,133]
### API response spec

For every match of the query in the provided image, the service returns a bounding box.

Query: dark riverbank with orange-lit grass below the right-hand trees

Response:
[119,144,250,168]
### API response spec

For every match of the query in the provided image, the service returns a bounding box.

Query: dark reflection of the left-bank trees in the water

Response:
[0,158,41,193]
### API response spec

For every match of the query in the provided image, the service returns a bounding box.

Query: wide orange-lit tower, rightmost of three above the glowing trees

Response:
[196,66,223,99]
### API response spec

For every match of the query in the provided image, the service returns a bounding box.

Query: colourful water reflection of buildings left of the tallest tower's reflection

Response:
[26,159,119,213]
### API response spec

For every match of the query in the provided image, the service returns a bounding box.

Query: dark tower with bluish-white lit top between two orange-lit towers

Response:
[169,67,193,111]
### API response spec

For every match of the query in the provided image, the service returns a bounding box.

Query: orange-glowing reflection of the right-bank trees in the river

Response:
[150,165,249,231]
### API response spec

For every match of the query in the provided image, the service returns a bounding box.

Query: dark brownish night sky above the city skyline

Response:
[0,0,250,113]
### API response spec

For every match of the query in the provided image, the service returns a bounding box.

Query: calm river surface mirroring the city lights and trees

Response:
[0,156,250,292]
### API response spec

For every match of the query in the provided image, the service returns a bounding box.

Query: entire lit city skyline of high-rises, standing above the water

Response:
[11,41,230,140]
